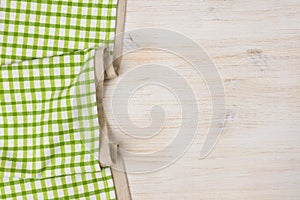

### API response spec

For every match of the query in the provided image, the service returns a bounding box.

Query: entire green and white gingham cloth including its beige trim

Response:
[0,0,130,199]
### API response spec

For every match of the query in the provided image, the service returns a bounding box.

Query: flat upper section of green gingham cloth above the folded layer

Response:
[0,0,117,64]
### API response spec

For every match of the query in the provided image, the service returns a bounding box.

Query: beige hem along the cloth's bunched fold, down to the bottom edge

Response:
[94,47,131,200]
